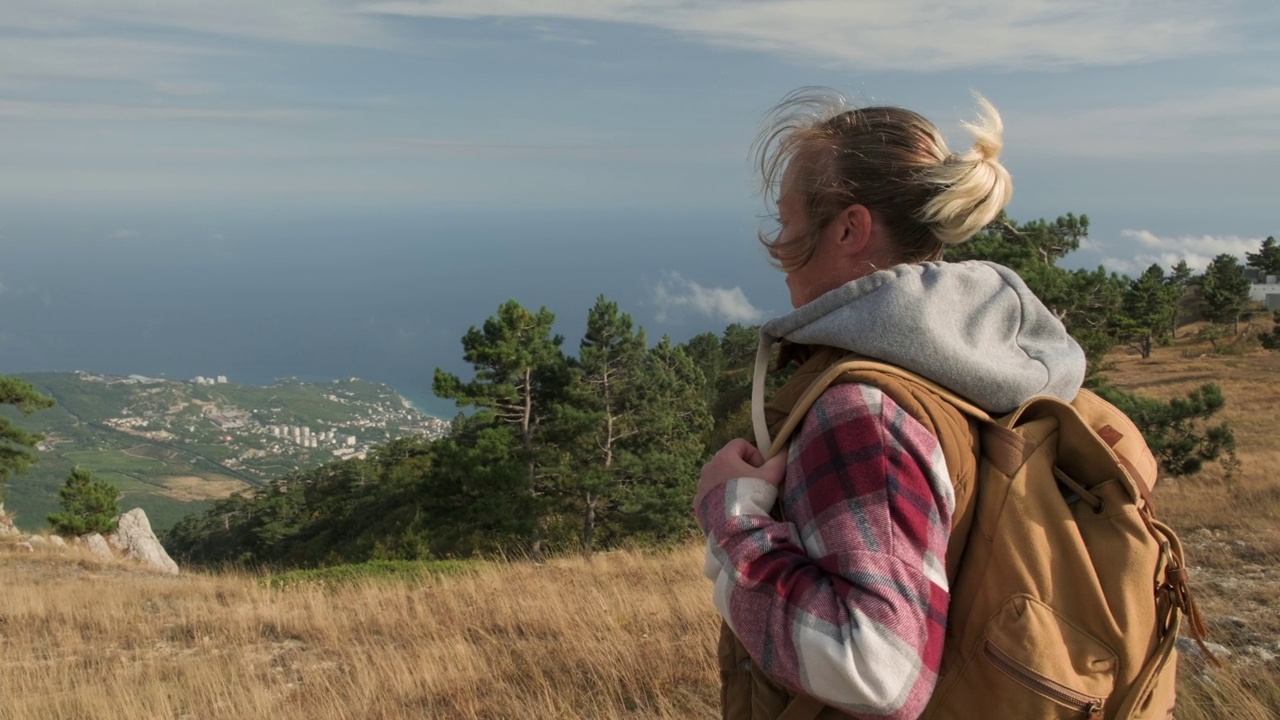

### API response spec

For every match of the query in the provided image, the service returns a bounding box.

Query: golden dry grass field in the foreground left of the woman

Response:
[0,548,718,720]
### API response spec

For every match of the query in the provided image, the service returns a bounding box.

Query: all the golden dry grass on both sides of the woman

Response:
[0,333,1280,720]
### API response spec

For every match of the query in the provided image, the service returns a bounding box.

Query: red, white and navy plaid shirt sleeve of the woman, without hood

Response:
[698,384,955,719]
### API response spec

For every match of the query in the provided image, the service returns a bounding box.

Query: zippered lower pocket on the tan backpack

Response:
[940,596,1117,720]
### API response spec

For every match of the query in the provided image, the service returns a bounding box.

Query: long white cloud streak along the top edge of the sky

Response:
[360,0,1248,72]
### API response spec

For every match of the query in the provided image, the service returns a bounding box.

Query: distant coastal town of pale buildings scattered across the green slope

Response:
[33,372,449,482]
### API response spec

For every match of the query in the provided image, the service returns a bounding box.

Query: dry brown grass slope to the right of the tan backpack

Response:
[1110,331,1280,720]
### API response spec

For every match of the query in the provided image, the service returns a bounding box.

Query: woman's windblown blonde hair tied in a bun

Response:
[754,88,1014,270]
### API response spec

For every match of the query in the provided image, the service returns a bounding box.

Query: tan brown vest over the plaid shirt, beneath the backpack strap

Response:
[718,346,978,720]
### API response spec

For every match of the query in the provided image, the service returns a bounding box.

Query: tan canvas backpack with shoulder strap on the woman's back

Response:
[747,359,1204,720]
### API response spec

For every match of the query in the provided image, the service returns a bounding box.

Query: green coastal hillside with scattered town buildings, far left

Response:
[0,373,447,529]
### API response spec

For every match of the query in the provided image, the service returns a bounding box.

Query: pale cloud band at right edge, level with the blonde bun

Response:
[1005,85,1280,158]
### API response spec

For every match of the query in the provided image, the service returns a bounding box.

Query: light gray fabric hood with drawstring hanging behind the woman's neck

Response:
[753,260,1084,445]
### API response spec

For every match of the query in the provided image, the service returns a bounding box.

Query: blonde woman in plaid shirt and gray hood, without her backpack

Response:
[694,88,1084,720]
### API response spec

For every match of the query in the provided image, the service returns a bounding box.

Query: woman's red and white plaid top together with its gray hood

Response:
[698,261,1084,717]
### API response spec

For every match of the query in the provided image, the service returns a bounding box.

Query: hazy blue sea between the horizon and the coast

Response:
[0,209,786,418]
